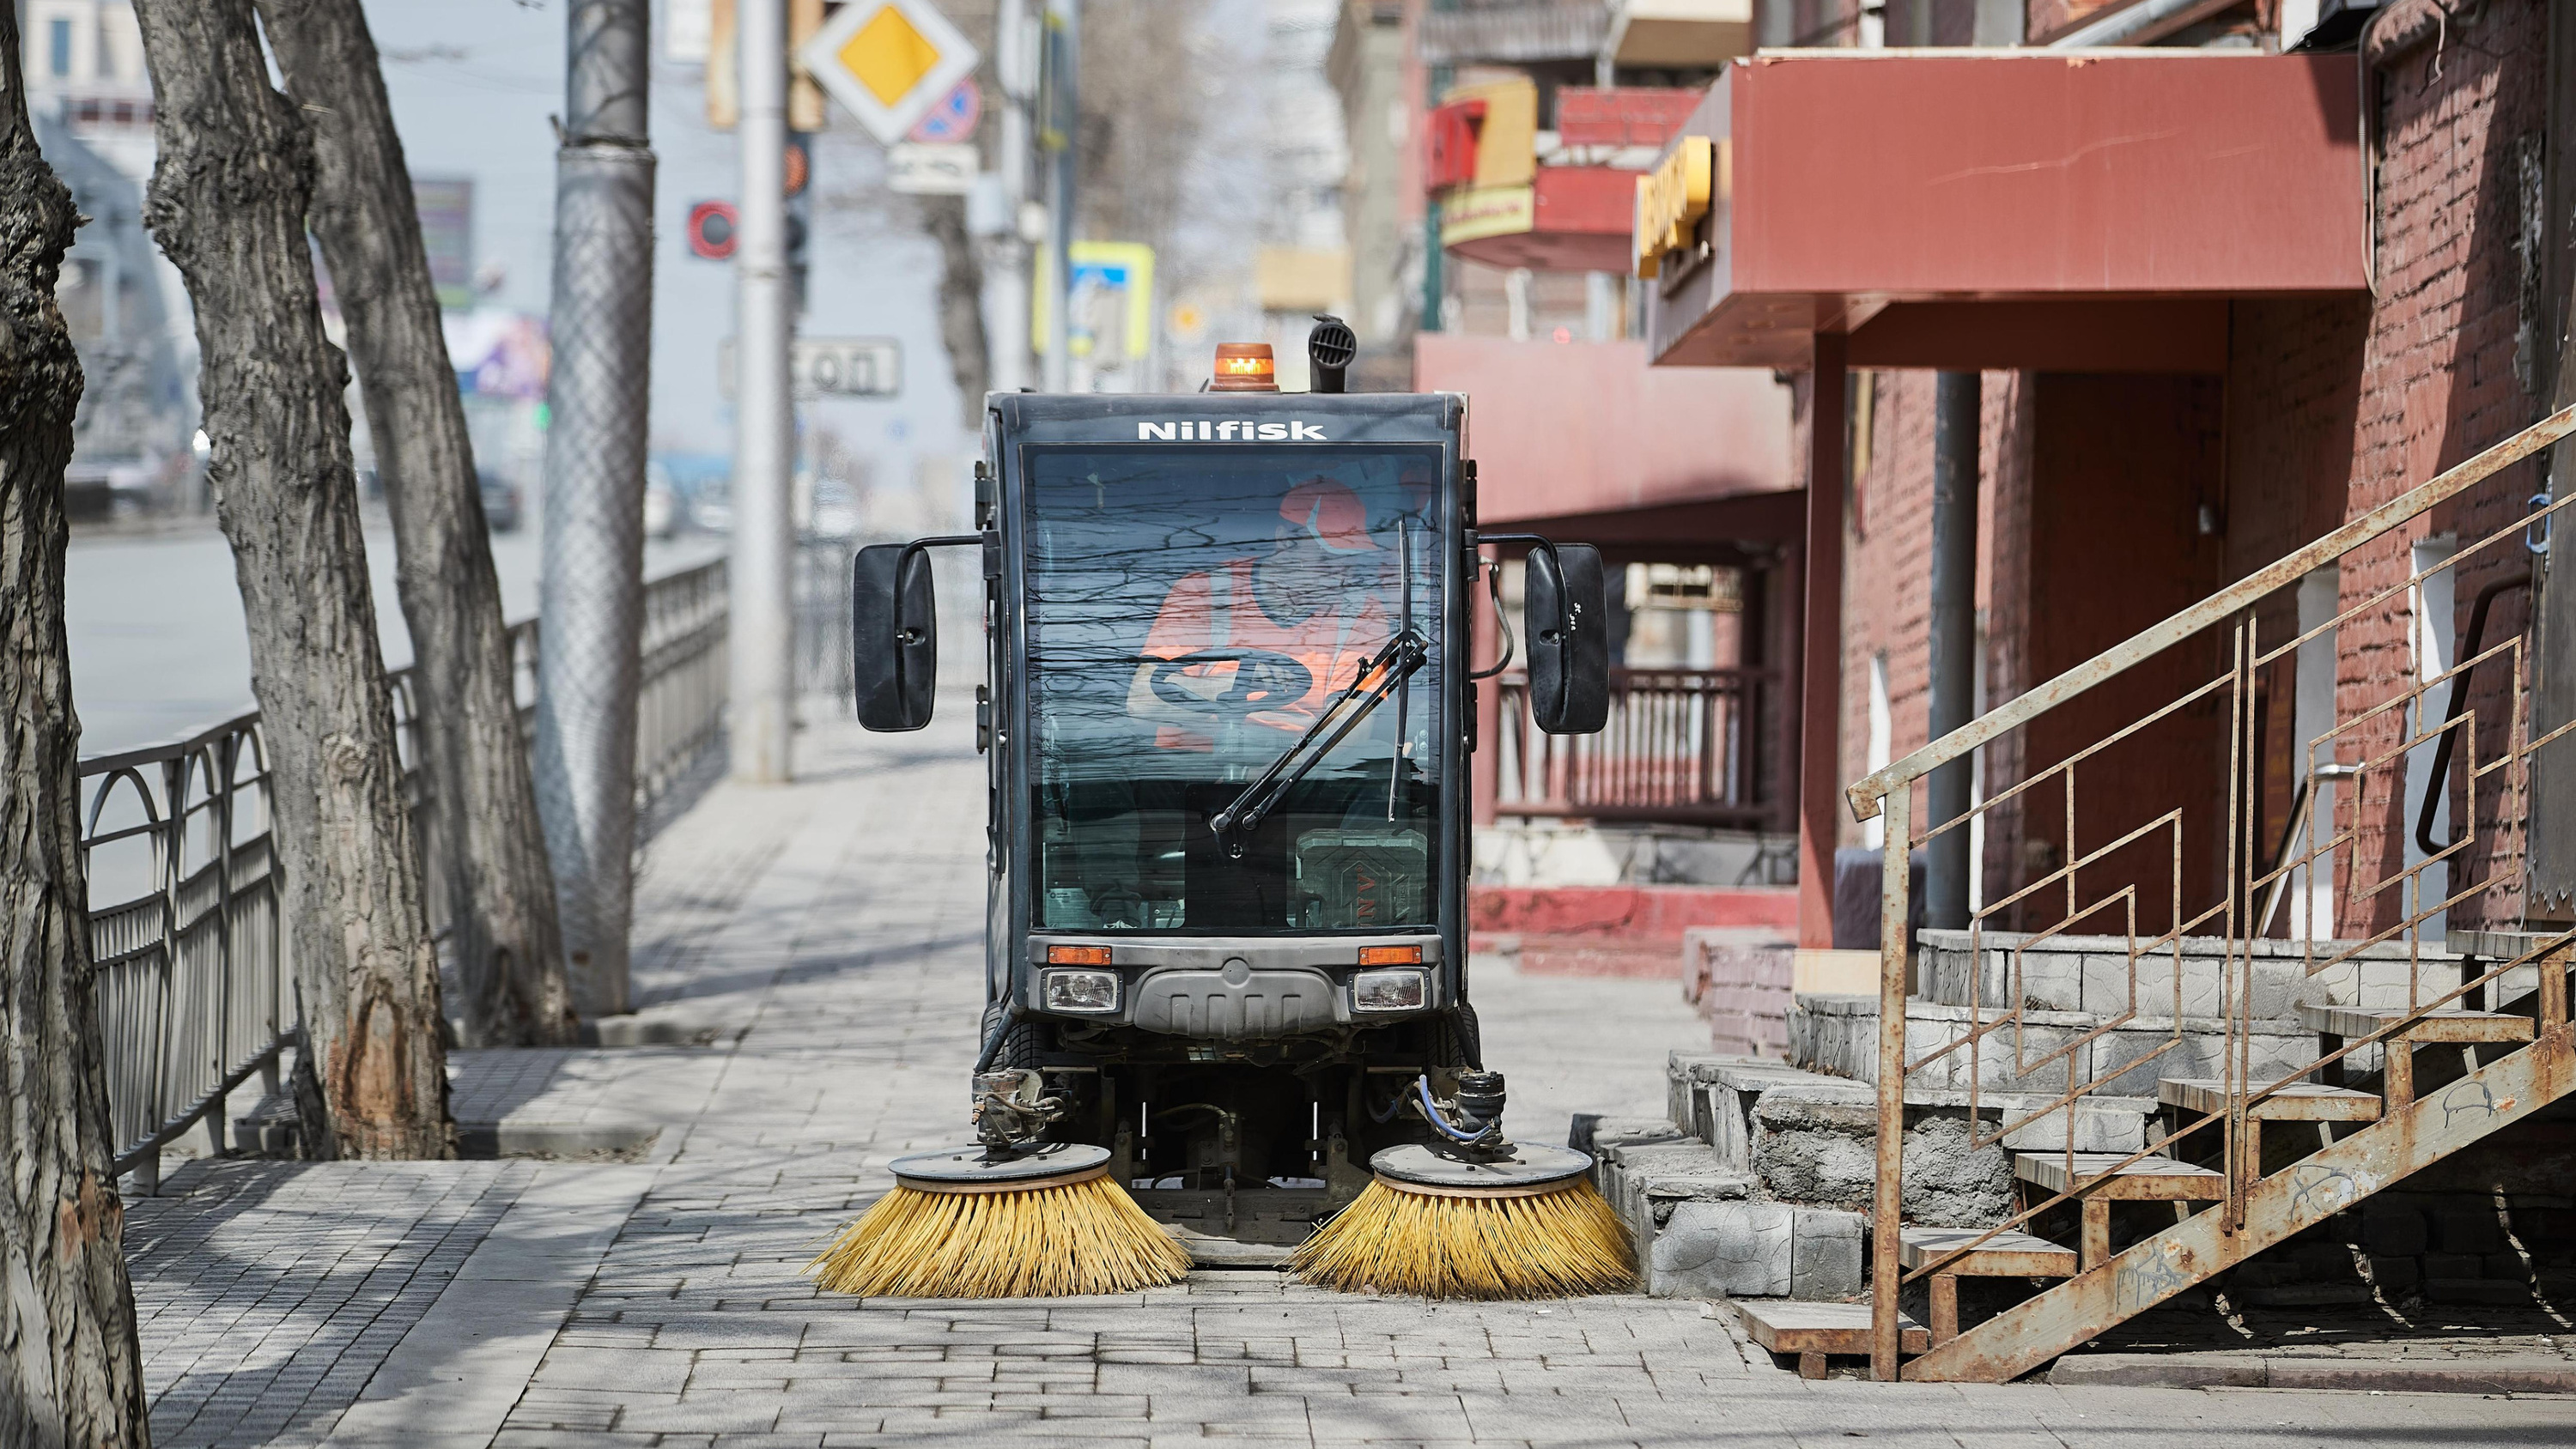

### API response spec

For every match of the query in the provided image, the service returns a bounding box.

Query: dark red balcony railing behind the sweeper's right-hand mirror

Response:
[1494,670,1790,828]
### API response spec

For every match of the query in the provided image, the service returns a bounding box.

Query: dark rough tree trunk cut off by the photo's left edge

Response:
[0,5,152,1449]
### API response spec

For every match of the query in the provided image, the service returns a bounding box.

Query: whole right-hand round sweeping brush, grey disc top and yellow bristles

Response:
[1288,1145,1636,1297]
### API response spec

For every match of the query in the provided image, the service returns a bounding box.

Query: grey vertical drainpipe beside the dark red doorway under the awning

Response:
[1924,373,1978,931]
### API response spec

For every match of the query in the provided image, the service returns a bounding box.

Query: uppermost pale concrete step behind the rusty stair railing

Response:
[1919,931,2504,1019]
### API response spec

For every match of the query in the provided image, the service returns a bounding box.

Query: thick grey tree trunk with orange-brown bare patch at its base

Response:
[134,0,456,1158]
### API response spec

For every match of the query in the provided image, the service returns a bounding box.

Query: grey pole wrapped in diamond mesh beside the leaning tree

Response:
[536,0,654,1016]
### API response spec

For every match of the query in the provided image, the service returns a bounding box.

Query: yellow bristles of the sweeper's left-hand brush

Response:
[806,1176,1190,1297]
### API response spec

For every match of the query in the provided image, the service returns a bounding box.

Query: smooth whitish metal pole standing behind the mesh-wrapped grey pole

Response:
[726,0,796,785]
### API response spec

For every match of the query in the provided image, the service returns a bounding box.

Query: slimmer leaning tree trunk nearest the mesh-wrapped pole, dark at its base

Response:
[258,0,577,1047]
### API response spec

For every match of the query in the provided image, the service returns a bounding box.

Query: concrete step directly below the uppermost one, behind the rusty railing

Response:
[1788,993,2318,1099]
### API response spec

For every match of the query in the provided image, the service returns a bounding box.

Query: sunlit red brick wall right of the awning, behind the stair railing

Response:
[2336,0,2548,937]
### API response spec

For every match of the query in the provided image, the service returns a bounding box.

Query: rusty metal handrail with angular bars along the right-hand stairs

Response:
[1847,407,2576,1377]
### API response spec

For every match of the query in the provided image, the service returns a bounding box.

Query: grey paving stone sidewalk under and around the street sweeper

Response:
[129,700,2576,1449]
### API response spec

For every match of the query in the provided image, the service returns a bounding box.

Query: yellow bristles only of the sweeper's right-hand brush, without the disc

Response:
[1288,1179,1636,1297]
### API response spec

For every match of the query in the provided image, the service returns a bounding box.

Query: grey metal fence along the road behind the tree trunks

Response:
[80,561,726,1191]
